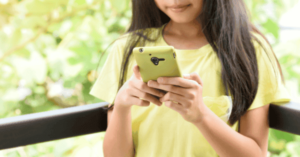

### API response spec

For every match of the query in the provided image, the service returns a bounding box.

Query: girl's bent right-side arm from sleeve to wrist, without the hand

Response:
[195,105,269,157]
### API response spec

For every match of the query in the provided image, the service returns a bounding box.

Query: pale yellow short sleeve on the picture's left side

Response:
[90,39,124,104]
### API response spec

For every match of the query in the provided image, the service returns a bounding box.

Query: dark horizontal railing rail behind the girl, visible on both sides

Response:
[0,102,300,149]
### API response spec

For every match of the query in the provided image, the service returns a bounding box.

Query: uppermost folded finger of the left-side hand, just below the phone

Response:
[131,81,165,98]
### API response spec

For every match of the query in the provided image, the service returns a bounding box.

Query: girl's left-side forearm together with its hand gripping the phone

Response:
[103,65,165,157]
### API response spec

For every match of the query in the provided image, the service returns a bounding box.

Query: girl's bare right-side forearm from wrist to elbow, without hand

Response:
[194,105,263,157]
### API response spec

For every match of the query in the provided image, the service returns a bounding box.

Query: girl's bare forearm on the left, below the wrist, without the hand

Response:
[103,105,134,157]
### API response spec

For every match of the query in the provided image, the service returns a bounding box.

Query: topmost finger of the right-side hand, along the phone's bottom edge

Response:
[157,77,194,88]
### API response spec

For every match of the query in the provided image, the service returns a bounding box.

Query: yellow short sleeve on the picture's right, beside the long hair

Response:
[248,34,291,110]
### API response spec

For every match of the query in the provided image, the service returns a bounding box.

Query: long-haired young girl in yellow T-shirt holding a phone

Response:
[91,0,290,157]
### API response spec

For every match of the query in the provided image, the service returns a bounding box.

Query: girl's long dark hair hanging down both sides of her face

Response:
[106,0,284,125]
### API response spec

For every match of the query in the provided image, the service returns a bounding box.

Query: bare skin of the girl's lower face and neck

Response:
[155,0,208,49]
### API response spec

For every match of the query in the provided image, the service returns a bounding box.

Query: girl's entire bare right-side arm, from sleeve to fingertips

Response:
[148,72,269,157]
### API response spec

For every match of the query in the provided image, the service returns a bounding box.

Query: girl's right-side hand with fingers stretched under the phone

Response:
[148,73,205,123]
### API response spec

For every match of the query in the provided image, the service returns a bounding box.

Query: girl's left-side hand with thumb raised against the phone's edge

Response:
[115,65,165,108]
